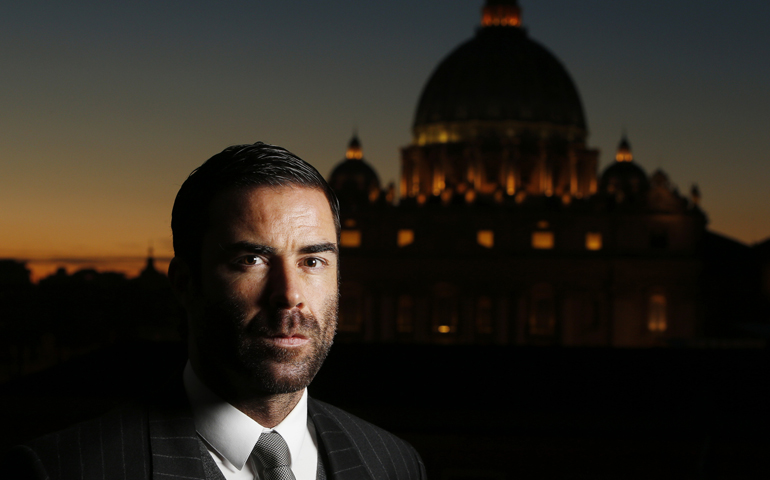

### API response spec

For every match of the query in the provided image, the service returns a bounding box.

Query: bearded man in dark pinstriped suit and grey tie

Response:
[0,143,425,480]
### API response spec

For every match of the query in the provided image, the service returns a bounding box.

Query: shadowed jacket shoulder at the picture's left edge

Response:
[0,407,150,480]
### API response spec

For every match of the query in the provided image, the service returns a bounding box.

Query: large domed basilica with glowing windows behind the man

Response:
[330,0,706,347]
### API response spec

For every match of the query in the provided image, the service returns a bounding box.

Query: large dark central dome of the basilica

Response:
[413,1,586,142]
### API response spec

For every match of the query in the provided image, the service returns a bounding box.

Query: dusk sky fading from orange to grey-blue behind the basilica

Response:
[0,0,770,278]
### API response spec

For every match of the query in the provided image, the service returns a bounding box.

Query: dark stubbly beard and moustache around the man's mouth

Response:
[195,295,339,394]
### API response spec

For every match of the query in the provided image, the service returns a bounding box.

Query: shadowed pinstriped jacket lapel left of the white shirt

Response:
[149,406,206,480]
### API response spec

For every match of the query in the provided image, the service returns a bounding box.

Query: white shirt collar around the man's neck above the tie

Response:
[183,361,308,470]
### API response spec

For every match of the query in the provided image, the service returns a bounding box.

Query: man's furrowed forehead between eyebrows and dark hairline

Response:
[208,186,336,240]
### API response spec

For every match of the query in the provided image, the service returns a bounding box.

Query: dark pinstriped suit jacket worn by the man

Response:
[0,398,426,480]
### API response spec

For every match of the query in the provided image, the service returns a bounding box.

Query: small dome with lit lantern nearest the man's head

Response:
[329,135,380,202]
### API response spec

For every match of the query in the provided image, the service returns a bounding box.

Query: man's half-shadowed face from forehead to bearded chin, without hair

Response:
[186,186,338,393]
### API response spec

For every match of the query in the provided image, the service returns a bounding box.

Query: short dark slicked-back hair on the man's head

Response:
[171,142,340,273]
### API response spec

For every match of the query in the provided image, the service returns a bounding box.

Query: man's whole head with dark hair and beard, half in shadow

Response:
[169,143,339,394]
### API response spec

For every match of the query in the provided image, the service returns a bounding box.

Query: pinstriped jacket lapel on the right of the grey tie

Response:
[307,398,372,480]
